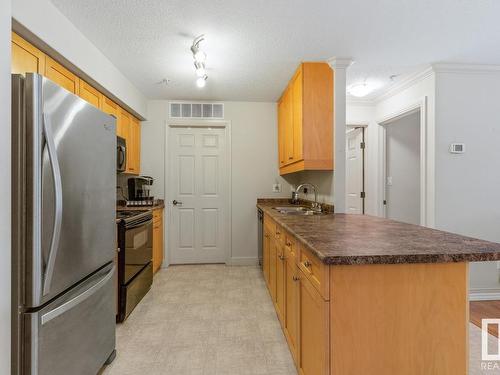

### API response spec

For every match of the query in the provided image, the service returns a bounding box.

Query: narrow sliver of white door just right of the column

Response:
[346,128,363,214]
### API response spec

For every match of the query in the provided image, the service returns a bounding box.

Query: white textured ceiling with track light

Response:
[51,0,500,101]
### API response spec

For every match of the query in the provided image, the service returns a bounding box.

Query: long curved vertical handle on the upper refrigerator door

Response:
[43,113,63,296]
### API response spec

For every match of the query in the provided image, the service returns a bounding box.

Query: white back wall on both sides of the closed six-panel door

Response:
[141,101,291,264]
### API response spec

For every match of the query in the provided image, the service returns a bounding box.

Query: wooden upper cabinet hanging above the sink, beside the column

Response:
[278,63,333,175]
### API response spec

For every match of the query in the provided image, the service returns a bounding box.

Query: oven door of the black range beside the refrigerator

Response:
[123,219,153,284]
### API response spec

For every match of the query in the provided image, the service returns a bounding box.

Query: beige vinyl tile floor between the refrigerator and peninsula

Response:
[102,265,500,375]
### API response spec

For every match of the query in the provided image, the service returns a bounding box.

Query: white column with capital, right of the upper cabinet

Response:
[327,57,353,213]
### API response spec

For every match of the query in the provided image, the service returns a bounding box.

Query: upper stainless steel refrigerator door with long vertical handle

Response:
[24,74,116,308]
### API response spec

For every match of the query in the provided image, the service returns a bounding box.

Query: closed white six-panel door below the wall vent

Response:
[169,127,229,264]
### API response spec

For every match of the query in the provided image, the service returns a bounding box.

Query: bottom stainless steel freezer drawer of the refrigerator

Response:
[23,264,115,375]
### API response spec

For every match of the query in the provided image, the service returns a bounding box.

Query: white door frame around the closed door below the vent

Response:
[164,119,232,266]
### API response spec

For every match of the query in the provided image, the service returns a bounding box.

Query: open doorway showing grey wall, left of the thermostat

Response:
[384,111,421,225]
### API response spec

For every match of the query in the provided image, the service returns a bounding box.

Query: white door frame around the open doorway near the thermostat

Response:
[377,96,428,226]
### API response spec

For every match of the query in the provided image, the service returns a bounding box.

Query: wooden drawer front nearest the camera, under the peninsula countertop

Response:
[299,246,330,301]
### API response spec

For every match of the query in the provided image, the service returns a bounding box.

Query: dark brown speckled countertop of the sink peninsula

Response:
[257,200,500,265]
